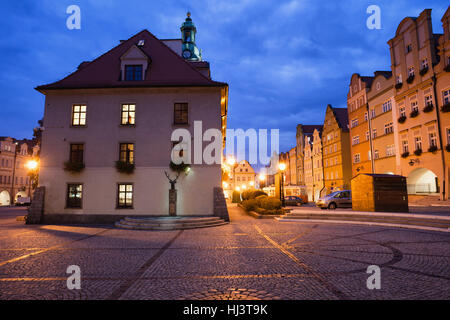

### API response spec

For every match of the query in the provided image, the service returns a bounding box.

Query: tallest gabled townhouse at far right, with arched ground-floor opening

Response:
[388,9,450,199]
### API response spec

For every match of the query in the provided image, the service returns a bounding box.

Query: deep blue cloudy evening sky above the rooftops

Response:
[0,0,448,155]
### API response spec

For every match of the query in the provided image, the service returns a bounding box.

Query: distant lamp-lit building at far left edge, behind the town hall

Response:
[0,137,39,206]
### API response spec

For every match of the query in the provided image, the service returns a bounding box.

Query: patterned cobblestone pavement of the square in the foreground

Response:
[0,206,450,300]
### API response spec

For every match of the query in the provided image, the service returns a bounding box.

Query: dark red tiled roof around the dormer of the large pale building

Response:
[36,30,228,92]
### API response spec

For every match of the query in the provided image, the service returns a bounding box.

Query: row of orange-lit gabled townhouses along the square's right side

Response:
[280,7,450,201]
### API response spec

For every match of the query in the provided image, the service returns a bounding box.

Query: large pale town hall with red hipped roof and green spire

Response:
[36,16,228,221]
